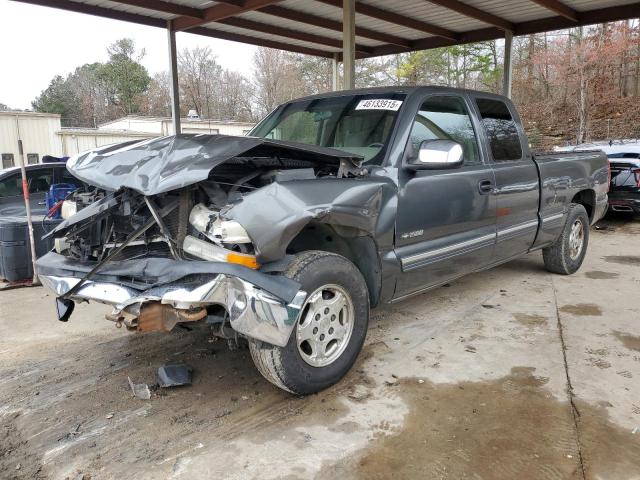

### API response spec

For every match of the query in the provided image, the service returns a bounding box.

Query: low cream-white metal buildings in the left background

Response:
[0,111,253,165]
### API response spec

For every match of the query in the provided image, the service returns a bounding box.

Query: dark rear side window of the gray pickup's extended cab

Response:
[476,98,522,162]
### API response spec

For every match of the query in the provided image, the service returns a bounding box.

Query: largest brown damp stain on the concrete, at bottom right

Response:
[316,367,640,480]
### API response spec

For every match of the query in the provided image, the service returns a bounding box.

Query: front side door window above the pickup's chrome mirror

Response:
[410,95,482,165]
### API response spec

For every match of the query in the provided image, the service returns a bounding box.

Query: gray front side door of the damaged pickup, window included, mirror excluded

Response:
[395,94,496,298]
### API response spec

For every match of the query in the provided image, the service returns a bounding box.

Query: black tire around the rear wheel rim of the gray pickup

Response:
[542,203,589,275]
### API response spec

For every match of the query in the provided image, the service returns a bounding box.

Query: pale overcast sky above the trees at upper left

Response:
[0,0,255,109]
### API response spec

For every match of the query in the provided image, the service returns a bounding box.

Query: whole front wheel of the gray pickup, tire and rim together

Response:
[249,251,369,395]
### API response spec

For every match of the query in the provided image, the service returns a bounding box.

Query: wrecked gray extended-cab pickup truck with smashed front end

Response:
[38,87,609,394]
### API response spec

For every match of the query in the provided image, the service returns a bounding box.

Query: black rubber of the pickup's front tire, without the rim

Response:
[249,251,369,395]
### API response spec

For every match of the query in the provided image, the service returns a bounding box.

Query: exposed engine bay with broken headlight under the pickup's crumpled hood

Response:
[55,161,324,268]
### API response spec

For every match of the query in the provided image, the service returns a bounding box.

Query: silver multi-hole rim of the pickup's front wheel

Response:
[296,284,354,367]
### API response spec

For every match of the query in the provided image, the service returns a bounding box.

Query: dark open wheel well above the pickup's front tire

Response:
[287,222,382,307]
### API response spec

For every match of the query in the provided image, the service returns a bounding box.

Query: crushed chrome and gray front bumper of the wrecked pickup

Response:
[37,252,307,347]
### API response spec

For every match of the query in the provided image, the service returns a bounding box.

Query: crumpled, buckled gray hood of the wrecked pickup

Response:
[67,134,362,195]
